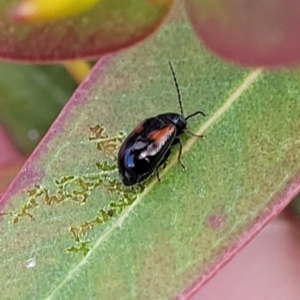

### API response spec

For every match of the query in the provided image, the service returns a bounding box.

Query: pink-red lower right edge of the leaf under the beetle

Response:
[178,175,300,300]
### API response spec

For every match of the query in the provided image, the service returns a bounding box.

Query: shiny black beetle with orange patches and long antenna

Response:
[118,61,205,186]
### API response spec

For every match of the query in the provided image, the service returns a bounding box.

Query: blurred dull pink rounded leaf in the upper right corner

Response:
[185,0,300,67]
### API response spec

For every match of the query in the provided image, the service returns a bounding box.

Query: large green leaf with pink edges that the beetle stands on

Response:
[0,1,300,299]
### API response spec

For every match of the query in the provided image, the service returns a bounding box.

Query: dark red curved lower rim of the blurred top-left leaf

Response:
[0,1,174,64]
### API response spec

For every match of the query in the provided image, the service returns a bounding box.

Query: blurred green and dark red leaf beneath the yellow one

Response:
[0,0,173,61]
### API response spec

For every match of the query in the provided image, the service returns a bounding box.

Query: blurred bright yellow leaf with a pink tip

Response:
[13,0,100,23]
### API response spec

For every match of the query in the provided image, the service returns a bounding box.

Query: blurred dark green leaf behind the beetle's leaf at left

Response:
[0,62,76,154]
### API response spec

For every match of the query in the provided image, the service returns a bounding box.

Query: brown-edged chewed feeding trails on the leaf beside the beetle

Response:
[0,125,144,255]
